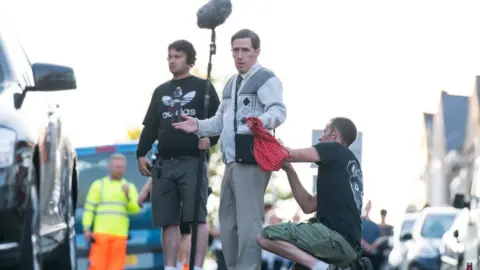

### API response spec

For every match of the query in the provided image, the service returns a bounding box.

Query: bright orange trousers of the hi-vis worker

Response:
[88,233,127,270]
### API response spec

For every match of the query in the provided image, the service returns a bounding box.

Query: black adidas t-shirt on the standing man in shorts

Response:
[137,76,220,156]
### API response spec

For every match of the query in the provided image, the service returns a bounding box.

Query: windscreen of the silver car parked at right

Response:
[420,213,457,238]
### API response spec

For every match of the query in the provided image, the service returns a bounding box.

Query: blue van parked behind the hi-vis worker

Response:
[75,142,164,270]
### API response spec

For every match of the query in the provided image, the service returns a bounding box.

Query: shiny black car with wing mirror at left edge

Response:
[0,32,77,270]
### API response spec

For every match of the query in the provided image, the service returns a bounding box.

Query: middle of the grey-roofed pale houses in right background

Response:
[427,91,469,206]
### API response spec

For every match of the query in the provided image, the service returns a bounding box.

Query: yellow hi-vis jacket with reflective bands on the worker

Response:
[82,176,140,236]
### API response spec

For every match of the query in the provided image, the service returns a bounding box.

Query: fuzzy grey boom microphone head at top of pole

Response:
[197,0,232,29]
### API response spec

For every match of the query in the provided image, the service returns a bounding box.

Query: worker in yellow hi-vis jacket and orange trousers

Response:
[82,154,141,270]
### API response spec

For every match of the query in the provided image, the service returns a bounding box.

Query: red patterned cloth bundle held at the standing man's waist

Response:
[247,117,288,171]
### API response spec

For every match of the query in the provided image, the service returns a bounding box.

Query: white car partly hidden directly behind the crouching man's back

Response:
[387,213,418,270]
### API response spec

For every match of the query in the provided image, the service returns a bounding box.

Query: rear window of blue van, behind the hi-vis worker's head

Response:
[77,152,147,207]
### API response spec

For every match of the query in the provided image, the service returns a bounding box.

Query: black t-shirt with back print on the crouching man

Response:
[314,142,363,248]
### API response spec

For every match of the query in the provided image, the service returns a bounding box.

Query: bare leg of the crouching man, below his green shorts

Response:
[257,236,320,269]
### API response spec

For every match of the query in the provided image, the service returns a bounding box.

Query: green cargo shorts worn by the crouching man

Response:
[263,221,357,268]
